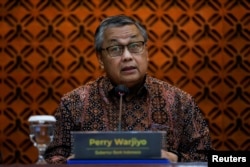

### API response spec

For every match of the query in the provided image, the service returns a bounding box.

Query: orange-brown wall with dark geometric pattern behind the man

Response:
[0,0,250,164]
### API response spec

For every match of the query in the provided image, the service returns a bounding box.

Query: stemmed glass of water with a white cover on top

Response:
[28,115,56,164]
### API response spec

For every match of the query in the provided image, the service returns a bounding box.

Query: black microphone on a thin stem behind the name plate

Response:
[115,85,129,131]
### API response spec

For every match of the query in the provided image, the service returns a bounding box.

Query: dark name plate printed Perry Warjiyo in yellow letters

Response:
[71,131,165,159]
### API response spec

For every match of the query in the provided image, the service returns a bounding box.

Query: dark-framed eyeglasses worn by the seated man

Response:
[102,41,145,57]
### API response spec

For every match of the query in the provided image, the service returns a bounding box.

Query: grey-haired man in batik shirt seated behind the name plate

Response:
[45,15,211,163]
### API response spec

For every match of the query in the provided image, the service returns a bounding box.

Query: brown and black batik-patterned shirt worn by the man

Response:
[45,75,211,163]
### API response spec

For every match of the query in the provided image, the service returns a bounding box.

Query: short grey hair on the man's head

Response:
[94,15,148,54]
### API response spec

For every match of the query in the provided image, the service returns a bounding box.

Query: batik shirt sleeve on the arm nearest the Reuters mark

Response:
[177,99,212,161]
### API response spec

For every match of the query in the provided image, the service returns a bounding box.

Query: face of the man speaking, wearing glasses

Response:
[98,25,148,88]
